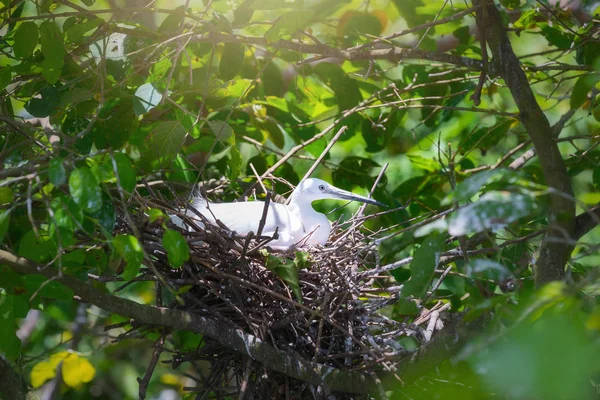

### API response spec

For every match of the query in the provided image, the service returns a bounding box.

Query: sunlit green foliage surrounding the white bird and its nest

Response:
[0,0,600,398]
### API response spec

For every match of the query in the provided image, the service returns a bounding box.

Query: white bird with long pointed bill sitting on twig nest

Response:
[176,178,386,250]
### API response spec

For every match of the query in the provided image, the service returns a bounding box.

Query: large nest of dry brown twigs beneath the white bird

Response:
[109,183,418,399]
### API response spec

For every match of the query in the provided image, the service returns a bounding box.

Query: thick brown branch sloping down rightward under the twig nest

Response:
[0,250,375,393]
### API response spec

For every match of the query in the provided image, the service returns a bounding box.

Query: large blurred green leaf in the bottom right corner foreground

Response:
[472,314,600,399]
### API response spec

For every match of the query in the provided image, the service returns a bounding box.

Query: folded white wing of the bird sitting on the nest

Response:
[200,201,304,238]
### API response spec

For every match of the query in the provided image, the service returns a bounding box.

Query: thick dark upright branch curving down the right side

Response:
[473,0,575,286]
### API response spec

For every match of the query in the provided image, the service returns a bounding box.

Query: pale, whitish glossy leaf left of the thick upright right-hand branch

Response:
[448,191,537,236]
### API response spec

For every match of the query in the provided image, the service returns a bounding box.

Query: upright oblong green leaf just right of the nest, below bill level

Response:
[402,233,446,298]
